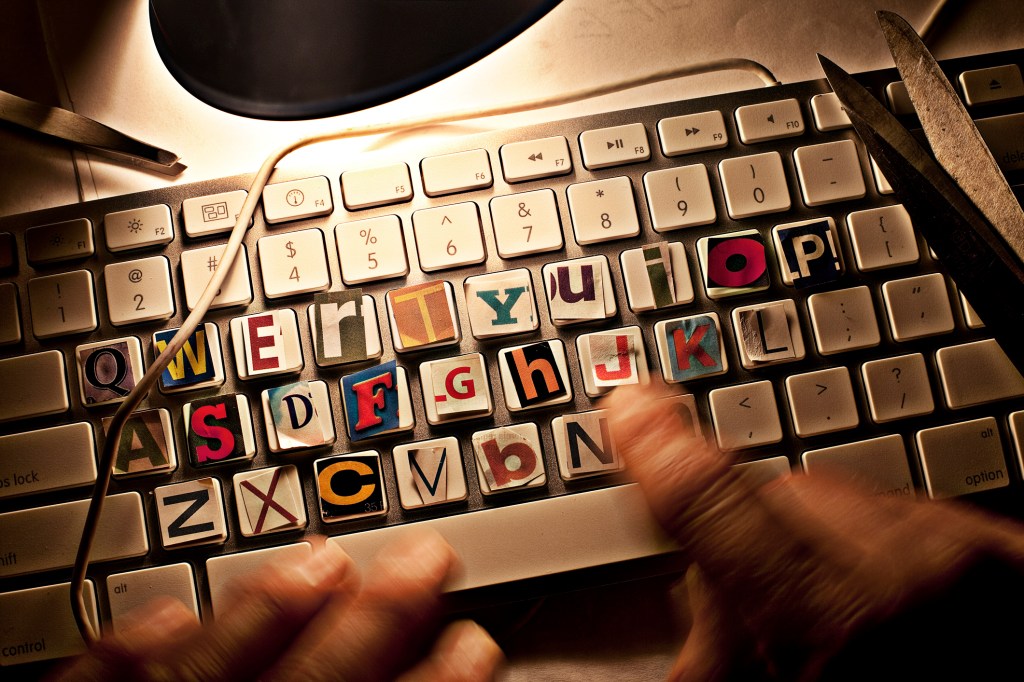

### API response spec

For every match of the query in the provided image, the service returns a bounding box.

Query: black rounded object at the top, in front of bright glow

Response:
[150,0,559,120]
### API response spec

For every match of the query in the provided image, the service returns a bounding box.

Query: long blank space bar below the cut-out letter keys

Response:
[331,484,676,592]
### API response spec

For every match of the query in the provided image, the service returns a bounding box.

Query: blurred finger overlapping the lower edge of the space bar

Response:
[268,529,457,681]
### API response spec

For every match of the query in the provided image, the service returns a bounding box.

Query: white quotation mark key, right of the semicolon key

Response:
[882,272,953,341]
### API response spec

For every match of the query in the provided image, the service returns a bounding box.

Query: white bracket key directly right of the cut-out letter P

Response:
[846,204,921,272]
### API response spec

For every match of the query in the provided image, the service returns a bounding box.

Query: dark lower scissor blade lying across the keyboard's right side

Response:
[818,54,1024,372]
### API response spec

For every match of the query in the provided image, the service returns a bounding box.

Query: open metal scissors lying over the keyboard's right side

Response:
[818,11,1024,373]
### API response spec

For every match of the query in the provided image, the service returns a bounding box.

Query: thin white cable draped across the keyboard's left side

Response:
[71,58,778,644]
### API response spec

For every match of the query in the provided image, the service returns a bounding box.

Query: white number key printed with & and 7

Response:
[490,187,563,258]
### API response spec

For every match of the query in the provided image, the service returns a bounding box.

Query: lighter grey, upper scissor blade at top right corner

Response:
[878,11,1024,262]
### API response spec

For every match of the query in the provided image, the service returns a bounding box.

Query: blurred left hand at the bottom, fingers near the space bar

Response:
[54,530,502,682]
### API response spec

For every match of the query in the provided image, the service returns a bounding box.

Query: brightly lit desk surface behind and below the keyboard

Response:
[0,0,1024,680]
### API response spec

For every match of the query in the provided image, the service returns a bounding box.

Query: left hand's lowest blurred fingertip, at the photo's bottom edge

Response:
[398,621,505,682]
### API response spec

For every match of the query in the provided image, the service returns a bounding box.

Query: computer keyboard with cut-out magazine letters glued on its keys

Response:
[0,50,1024,666]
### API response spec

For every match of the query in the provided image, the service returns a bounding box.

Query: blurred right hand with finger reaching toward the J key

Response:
[602,386,1024,680]
